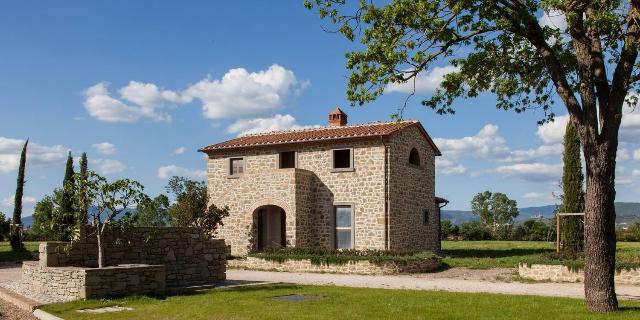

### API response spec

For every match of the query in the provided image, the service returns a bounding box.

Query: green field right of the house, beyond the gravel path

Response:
[442,241,640,269]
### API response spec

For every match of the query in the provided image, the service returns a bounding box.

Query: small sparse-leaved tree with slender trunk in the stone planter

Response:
[75,171,146,268]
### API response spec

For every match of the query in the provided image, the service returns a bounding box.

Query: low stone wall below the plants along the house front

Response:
[227,257,441,274]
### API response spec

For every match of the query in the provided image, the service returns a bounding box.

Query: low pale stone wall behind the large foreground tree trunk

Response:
[518,264,640,285]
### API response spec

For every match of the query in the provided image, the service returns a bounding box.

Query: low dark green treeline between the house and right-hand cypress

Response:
[440,220,556,241]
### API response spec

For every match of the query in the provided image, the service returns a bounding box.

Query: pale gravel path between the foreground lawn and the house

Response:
[227,269,640,300]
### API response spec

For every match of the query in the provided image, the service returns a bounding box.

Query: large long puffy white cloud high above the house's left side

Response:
[84,64,308,123]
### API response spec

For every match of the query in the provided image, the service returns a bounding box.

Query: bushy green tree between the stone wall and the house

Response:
[167,176,229,234]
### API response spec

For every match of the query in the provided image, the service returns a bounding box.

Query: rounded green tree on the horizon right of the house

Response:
[471,191,518,238]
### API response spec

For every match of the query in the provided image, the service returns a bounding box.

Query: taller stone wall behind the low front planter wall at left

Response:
[40,228,226,287]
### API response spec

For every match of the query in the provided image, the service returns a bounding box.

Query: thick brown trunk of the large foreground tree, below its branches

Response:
[583,140,618,312]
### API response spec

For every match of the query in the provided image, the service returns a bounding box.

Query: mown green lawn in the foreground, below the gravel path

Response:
[42,285,640,320]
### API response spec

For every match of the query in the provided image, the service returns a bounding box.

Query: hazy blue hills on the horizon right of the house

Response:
[441,202,640,225]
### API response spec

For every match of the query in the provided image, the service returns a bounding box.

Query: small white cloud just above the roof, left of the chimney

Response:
[227,114,319,135]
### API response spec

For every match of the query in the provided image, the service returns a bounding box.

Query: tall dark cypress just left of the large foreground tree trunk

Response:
[561,122,584,255]
